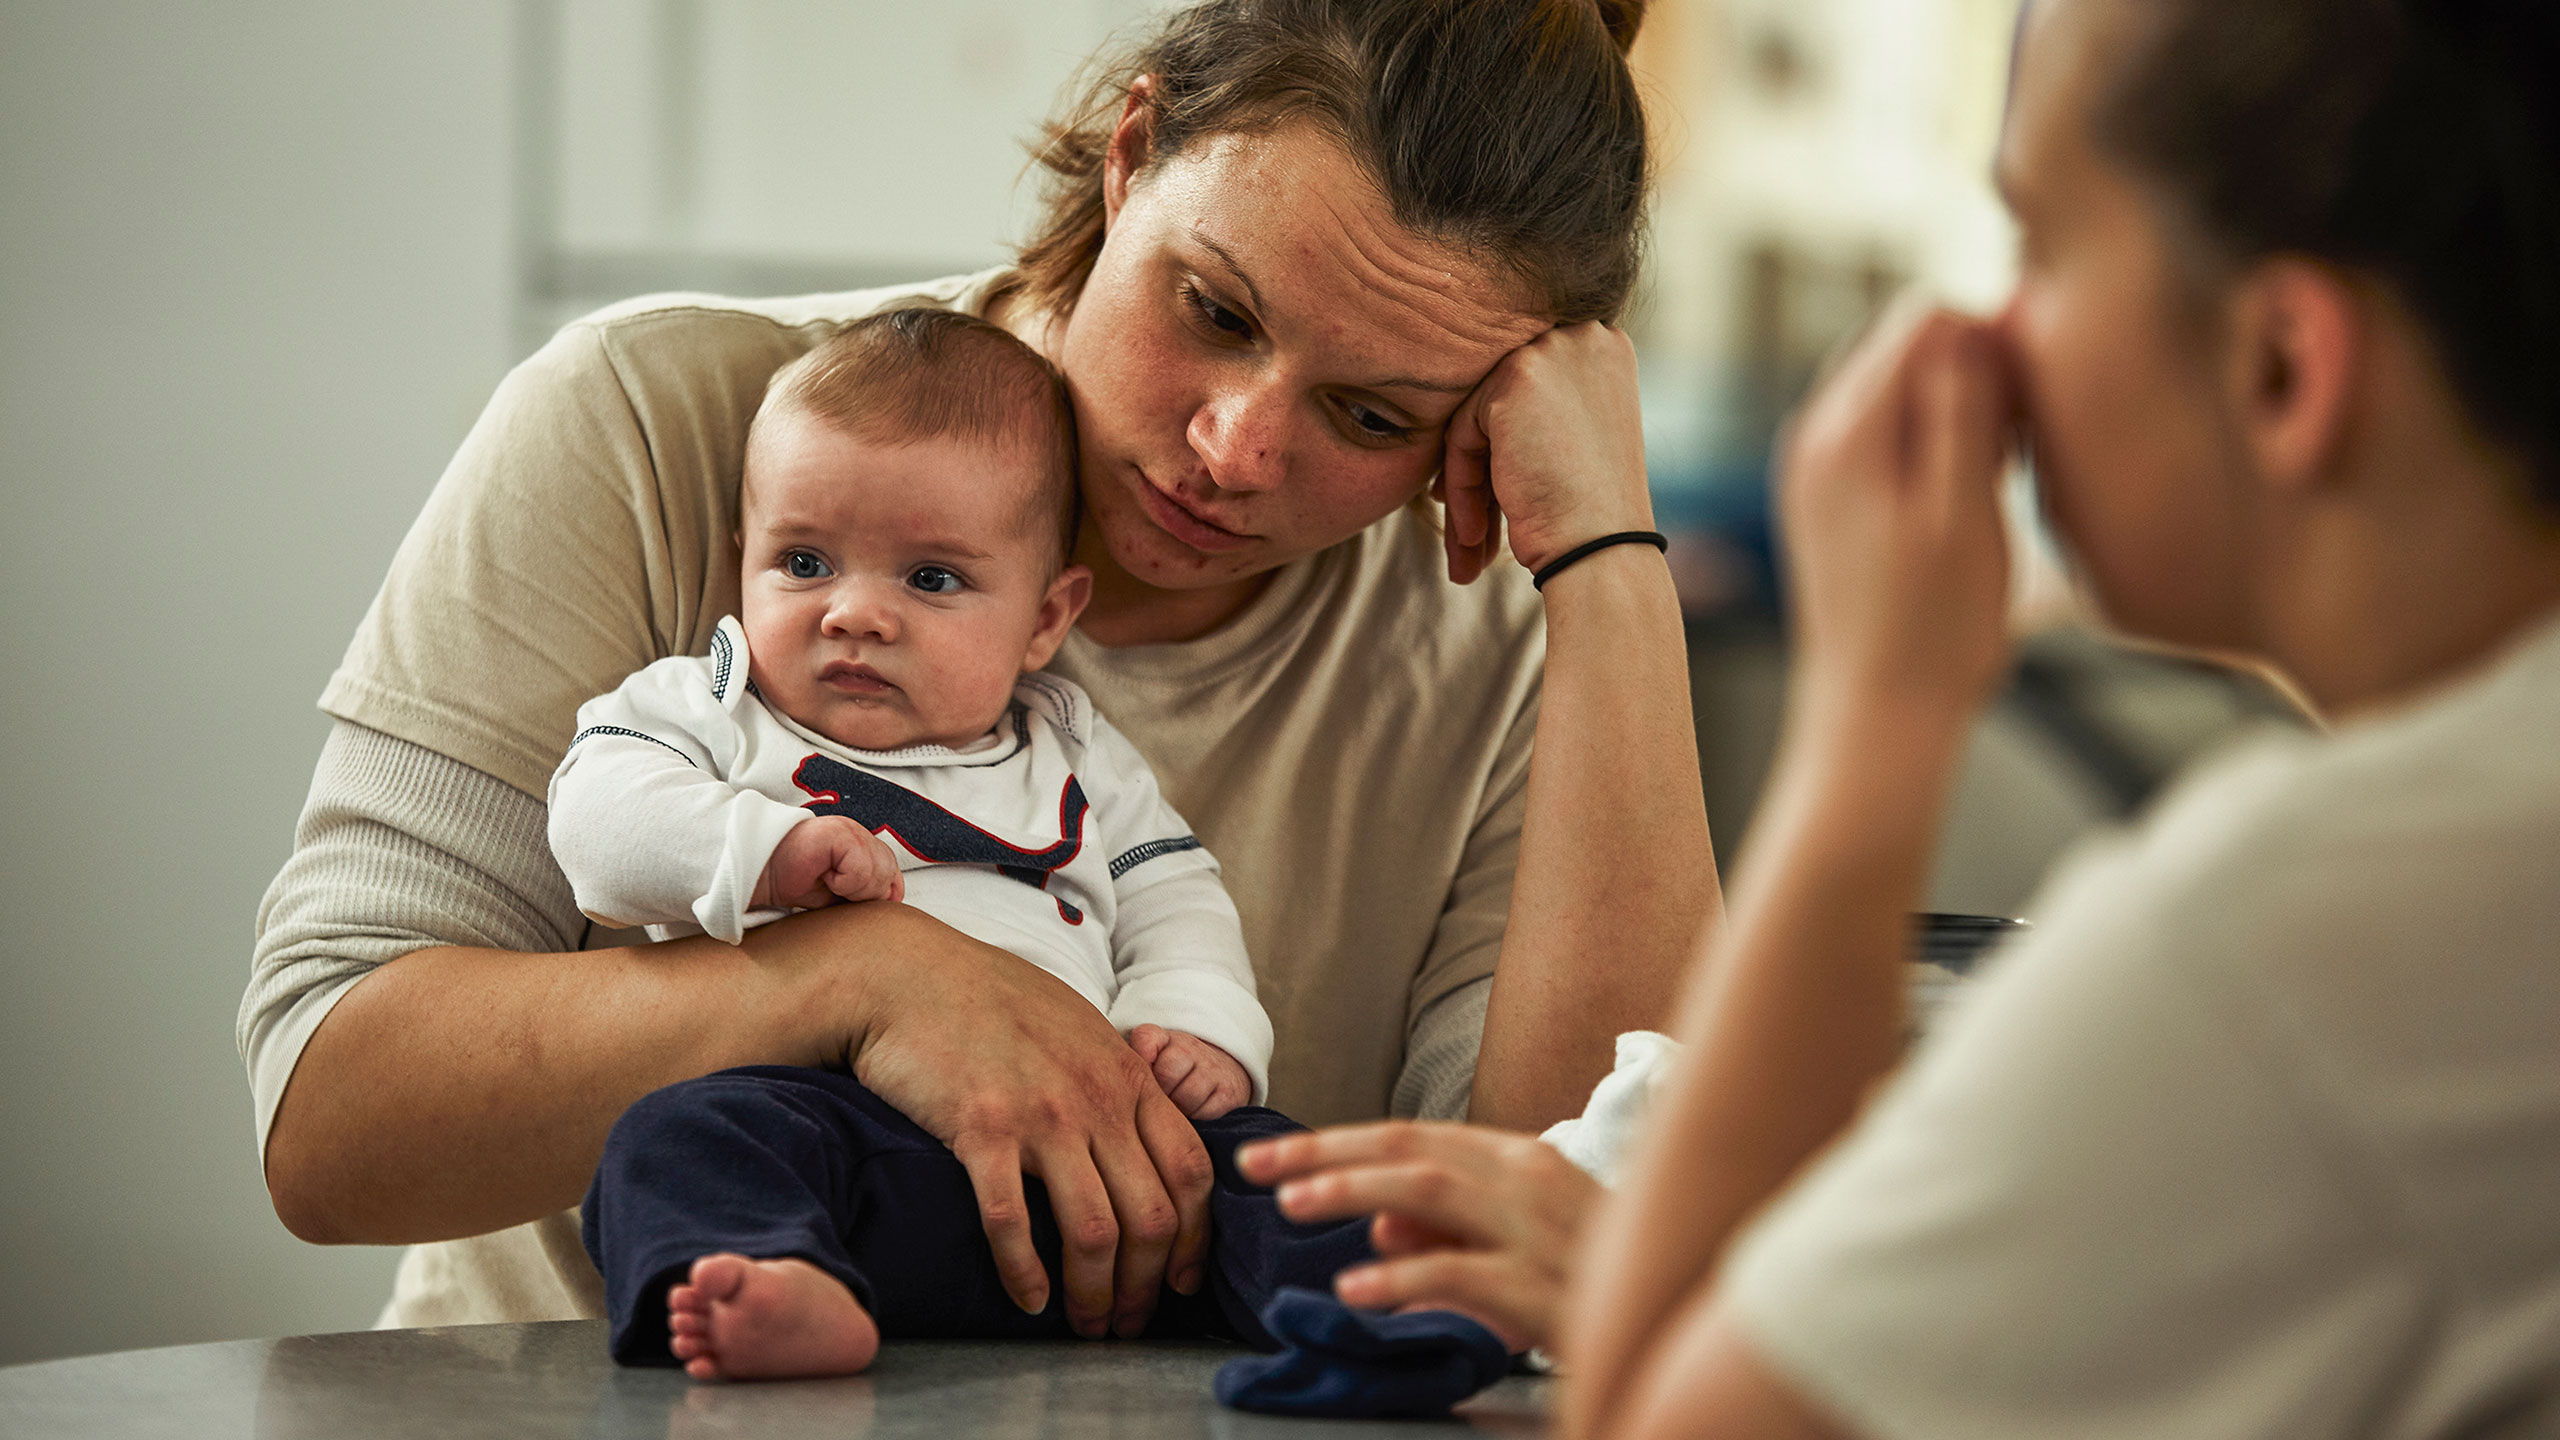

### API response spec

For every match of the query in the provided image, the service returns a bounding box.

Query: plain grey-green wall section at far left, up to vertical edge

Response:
[0,0,515,1361]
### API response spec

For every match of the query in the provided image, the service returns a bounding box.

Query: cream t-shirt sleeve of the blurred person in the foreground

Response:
[1720,830,2427,1440]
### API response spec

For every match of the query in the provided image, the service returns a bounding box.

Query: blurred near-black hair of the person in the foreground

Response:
[2092,0,2560,515]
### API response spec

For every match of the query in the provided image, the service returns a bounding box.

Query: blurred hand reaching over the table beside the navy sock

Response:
[1236,1120,1605,1350]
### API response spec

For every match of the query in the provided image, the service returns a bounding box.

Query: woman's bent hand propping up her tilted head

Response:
[1434,320,1654,584]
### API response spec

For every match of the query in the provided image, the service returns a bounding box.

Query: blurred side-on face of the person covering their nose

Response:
[1999,0,2245,648]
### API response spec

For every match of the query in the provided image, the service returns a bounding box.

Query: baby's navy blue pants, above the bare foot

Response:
[581,1066,1375,1366]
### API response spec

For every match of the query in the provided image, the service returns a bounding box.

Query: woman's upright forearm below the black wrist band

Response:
[1469,546,1718,1130]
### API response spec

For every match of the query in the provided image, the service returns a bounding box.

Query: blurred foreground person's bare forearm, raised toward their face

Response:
[1567,696,1964,1435]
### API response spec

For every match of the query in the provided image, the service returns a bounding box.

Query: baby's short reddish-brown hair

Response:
[755,305,1080,564]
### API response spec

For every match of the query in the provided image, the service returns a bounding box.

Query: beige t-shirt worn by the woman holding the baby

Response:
[320,272,1546,1325]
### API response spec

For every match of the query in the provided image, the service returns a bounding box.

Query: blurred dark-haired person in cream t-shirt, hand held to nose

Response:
[1247,0,2560,1437]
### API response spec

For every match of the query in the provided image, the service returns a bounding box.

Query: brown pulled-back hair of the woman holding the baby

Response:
[1016,0,1646,325]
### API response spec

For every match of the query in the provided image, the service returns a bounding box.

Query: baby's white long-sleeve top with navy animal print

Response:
[550,618,1272,1104]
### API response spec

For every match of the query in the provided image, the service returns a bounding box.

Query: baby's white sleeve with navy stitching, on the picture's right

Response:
[1078,717,1272,1104]
